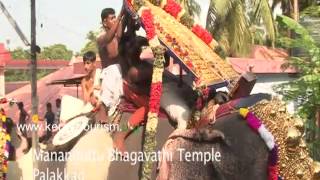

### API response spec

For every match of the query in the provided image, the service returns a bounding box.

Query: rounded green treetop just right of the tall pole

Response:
[38,44,73,60]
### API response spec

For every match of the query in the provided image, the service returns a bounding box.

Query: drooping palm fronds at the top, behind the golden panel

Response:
[206,0,276,55]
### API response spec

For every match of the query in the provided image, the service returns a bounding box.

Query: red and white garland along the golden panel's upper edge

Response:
[151,0,216,48]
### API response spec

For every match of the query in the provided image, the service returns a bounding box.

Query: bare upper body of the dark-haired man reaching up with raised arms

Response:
[97,8,124,69]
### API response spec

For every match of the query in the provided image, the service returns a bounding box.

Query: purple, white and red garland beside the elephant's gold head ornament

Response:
[239,108,278,180]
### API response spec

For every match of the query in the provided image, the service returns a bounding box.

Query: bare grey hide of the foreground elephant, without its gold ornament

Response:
[157,94,271,180]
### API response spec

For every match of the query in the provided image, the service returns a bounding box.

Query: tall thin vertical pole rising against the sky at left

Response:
[30,0,39,174]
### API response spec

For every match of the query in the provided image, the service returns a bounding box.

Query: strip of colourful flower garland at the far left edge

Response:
[0,113,11,179]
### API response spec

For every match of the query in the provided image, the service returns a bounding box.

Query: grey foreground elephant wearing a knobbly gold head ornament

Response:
[157,94,320,180]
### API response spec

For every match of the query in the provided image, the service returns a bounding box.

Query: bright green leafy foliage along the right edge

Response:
[277,16,320,160]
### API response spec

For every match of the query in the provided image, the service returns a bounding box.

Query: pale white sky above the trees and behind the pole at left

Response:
[0,0,209,52]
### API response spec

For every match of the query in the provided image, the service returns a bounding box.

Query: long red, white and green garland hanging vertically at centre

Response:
[127,0,165,179]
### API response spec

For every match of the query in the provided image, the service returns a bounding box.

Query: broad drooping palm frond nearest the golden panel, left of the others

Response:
[206,0,252,55]
